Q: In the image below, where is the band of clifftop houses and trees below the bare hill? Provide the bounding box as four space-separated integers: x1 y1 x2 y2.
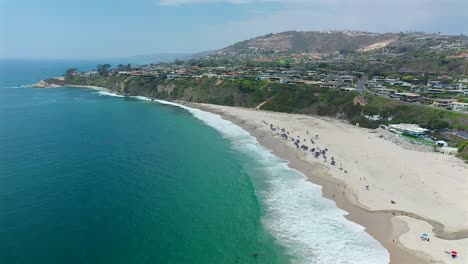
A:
74 64 468 112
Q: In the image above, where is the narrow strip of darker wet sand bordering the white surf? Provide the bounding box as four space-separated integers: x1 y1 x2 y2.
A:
194 103 432 264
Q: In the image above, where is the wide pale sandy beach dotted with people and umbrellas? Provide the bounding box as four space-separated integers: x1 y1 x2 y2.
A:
196 104 468 264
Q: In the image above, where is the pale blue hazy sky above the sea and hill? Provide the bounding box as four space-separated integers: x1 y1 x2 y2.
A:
0 0 468 59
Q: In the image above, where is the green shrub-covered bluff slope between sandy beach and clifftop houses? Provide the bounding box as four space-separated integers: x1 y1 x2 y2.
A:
63 74 468 133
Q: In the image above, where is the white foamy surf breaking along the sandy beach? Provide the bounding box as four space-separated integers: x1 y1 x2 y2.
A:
156 100 390 264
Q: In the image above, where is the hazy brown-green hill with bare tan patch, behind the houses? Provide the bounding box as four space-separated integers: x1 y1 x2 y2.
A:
214 31 468 75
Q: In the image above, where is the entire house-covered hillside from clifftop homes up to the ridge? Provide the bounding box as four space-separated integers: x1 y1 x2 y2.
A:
62 31 468 112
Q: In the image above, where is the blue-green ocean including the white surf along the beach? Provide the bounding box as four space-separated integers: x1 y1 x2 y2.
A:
0 61 389 264
